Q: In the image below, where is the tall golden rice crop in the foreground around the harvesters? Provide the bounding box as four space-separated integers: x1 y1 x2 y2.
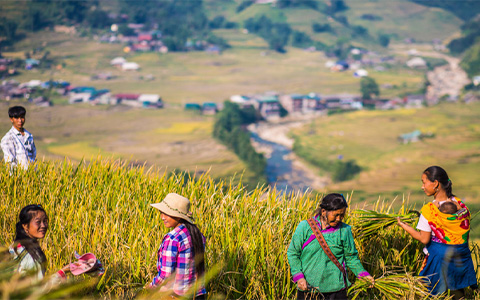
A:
0 158 480 299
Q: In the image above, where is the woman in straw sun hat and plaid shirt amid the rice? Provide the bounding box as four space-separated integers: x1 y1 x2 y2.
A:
149 193 207 299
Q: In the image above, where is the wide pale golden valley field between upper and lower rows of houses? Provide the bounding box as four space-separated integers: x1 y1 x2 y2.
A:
2 29 423 105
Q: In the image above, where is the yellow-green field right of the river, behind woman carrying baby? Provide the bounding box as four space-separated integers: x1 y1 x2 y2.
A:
292 103 480 207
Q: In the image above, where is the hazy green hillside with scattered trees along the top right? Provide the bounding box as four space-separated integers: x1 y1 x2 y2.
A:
204 0 463 47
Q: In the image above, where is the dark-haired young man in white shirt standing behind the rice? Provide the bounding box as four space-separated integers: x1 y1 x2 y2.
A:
1 106 37 169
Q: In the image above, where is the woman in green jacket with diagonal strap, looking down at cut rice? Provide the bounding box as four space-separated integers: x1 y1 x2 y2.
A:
287 193 374 300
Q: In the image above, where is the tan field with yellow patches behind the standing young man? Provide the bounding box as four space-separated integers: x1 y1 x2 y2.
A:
0 102 245 177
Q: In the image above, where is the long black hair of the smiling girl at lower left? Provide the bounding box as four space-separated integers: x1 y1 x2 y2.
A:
14 204 47 264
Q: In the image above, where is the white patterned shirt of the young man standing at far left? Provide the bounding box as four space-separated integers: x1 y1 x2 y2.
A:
1 126 37 169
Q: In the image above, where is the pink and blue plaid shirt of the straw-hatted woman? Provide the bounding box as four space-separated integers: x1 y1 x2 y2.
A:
151 224 207 296
